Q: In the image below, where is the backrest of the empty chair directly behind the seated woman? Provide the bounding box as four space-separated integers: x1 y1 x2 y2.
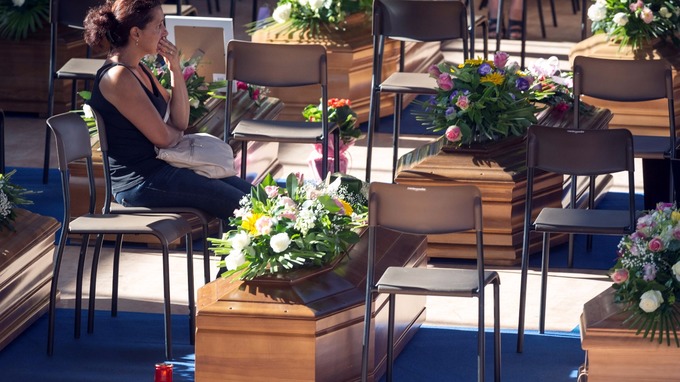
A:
47 112 96 224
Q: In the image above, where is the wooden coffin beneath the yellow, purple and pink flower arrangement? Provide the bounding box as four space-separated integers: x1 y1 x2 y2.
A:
395 109 611 265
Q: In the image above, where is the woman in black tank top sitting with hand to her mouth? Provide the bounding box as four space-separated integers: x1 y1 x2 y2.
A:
85 0 251 220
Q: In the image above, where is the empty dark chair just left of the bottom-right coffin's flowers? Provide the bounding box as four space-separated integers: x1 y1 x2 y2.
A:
517 125 635 352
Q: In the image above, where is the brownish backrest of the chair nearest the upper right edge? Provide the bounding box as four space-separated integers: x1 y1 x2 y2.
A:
574 56 677 157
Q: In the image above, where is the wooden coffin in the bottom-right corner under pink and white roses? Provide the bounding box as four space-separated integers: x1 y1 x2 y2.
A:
581 288 680 382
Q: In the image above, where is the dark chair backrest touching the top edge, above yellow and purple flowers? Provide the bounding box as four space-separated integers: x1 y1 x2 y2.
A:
373 0 468 46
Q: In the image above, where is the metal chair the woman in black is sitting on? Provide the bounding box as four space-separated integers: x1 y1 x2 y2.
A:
91 108 222 286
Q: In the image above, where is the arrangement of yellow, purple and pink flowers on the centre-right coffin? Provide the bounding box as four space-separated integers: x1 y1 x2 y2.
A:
414 52 539 146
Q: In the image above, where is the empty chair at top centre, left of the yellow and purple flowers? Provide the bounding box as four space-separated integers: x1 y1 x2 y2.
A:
366 0 488 182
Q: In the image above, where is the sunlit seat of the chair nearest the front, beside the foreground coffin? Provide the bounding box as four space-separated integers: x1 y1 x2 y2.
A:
376 267 500 297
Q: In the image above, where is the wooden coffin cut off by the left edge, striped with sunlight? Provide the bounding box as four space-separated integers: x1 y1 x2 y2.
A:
0 208 60 350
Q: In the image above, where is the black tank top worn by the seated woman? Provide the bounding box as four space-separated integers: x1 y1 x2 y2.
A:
88 62 169 195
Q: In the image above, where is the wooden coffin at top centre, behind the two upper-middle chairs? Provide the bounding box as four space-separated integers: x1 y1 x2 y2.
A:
252 14 444 123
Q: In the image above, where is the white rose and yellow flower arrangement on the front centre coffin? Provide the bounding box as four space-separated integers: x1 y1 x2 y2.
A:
209 174 368 280
